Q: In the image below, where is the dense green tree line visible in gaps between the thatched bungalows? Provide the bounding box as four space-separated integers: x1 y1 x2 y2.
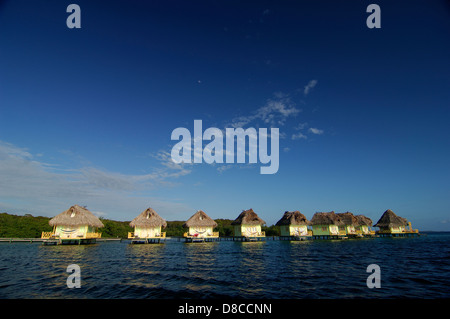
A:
0 213 280 238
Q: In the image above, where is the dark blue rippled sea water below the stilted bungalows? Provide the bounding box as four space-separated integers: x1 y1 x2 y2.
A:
0 233 450 299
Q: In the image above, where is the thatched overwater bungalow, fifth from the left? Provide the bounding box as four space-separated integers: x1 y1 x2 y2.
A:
275 211 312 239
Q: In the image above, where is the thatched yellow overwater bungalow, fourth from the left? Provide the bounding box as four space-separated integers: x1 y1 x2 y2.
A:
231 208 266 241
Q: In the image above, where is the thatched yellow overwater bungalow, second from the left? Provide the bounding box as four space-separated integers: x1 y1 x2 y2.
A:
128 208 167 244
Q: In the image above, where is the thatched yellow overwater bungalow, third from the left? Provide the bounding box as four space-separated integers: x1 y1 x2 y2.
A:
183 210 219 242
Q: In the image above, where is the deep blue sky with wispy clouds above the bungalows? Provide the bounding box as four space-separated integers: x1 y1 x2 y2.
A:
0 0 450 230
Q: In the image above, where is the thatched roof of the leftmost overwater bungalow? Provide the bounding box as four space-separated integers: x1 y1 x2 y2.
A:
48 205 104 227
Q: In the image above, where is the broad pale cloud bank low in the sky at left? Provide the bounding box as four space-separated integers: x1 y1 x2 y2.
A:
0 141 190 220
